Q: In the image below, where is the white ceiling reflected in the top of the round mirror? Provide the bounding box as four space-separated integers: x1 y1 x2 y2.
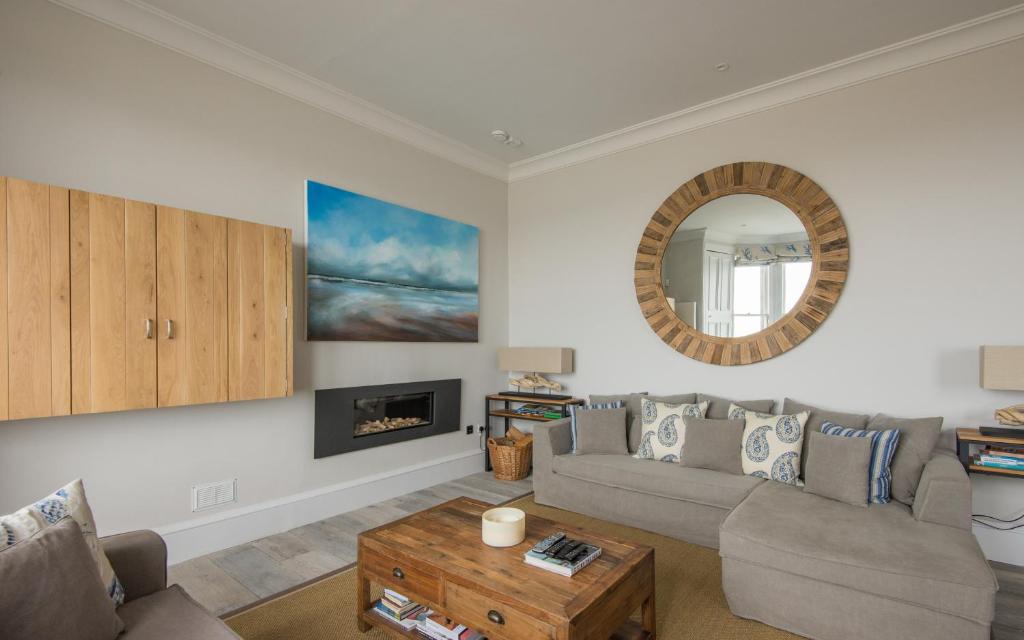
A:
677 194 807 237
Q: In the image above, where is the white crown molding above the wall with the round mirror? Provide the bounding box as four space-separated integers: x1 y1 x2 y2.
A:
509 4 1024 182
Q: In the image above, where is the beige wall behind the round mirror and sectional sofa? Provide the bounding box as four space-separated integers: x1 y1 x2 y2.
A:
509 41 1024 564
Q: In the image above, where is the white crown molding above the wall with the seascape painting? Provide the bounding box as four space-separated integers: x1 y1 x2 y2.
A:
50 0 508 181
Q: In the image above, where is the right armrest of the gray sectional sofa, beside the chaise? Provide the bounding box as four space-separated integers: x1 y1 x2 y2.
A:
913 454 971 530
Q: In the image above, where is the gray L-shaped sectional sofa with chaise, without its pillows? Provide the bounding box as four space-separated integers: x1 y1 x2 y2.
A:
534 395 997 640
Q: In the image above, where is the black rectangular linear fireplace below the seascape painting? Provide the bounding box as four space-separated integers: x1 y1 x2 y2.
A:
313 379 462 458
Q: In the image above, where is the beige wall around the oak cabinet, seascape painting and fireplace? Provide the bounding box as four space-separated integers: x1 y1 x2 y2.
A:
0 1 508 531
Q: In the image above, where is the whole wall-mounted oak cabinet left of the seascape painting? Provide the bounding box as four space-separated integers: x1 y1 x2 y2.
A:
0 177 293 420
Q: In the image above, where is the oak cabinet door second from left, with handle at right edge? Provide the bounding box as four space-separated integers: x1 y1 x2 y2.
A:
71 191 157 413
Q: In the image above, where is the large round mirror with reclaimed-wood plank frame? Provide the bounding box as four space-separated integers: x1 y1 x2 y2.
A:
634 162 850 365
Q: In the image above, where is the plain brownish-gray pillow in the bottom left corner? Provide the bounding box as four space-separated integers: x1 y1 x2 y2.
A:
0 516 124 640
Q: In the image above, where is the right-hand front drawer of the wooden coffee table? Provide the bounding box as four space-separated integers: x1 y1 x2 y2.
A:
444 583 555 640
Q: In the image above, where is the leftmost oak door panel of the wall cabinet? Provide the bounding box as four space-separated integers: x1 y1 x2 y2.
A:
0 178 71 420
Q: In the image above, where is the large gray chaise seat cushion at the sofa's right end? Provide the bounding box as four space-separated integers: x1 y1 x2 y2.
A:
719 482 996 624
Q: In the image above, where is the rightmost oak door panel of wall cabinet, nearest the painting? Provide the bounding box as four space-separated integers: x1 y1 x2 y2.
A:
227 220 292 400
